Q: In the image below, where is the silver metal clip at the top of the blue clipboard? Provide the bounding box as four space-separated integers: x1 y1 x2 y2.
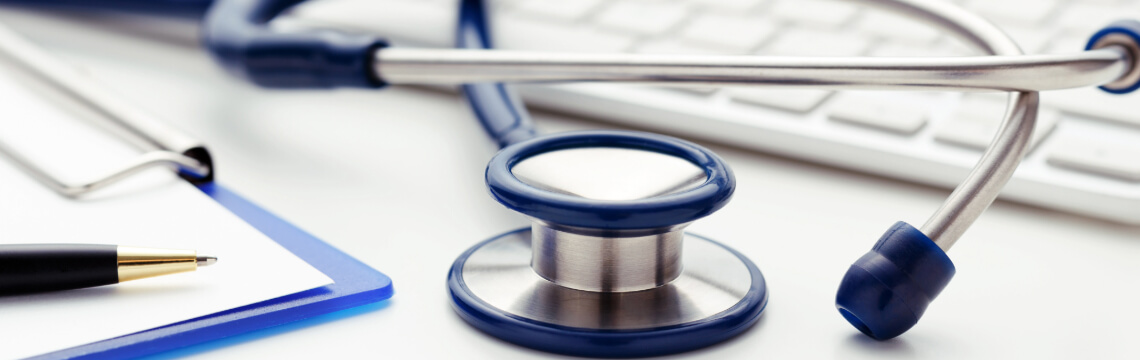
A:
0 25 213 198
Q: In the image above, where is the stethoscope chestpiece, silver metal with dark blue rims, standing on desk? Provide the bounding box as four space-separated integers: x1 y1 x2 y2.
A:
448 131 767 358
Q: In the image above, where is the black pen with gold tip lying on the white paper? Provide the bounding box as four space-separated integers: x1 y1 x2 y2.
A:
0 244 218 295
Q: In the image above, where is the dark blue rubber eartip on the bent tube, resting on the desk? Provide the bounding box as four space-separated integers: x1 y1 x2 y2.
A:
836 221 954 339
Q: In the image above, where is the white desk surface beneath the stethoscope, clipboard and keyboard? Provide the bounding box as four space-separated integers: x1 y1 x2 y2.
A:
0 7 1140 359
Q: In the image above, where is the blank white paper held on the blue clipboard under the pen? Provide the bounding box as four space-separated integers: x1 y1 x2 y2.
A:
0 61 332 359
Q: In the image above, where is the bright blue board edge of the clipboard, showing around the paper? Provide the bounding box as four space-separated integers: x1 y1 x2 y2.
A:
32 182 392 359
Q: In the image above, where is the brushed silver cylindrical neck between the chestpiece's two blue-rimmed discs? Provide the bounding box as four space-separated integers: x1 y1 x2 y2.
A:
530 222 685 293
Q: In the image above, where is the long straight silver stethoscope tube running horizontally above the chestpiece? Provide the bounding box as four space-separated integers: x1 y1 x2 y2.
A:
373 48 1129 91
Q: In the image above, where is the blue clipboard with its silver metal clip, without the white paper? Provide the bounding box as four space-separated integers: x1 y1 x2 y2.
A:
0 20 392 359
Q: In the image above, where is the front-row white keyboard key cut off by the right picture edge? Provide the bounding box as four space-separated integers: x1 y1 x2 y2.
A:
1048 138 1140 181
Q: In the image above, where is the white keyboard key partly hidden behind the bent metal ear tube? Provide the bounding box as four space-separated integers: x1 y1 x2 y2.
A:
934 97 1060 152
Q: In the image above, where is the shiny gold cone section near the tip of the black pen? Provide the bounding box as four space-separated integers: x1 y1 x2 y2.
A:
117 246 198 283
